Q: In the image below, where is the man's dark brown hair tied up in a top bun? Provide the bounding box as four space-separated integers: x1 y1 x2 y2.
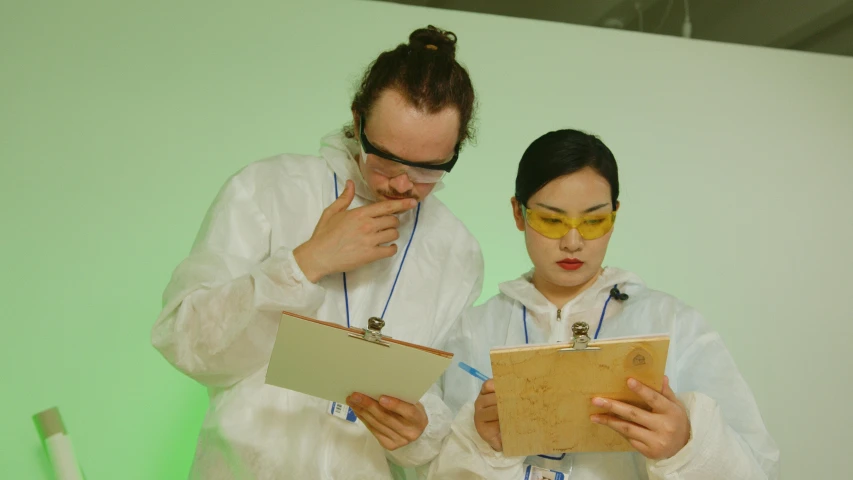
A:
346 25 475 144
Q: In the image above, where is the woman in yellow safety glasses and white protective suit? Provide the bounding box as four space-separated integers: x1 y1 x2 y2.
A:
430 130 779 480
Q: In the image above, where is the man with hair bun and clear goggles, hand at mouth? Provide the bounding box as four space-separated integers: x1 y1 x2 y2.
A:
152 26 483 480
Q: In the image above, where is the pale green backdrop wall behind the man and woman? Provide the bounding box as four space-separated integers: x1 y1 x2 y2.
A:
5 0 853 480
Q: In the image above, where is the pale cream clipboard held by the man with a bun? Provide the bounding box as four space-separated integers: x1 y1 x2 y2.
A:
265 312 453 404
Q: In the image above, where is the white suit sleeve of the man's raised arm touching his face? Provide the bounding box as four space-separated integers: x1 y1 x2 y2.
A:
151 173 325 388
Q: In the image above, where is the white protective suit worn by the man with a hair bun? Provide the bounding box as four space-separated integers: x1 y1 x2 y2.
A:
152 133 483 480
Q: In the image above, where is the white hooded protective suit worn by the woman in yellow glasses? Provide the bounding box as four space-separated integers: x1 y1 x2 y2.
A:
430 268 779 480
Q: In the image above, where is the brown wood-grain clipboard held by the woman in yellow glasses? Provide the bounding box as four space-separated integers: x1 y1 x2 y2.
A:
490 322 669 456
